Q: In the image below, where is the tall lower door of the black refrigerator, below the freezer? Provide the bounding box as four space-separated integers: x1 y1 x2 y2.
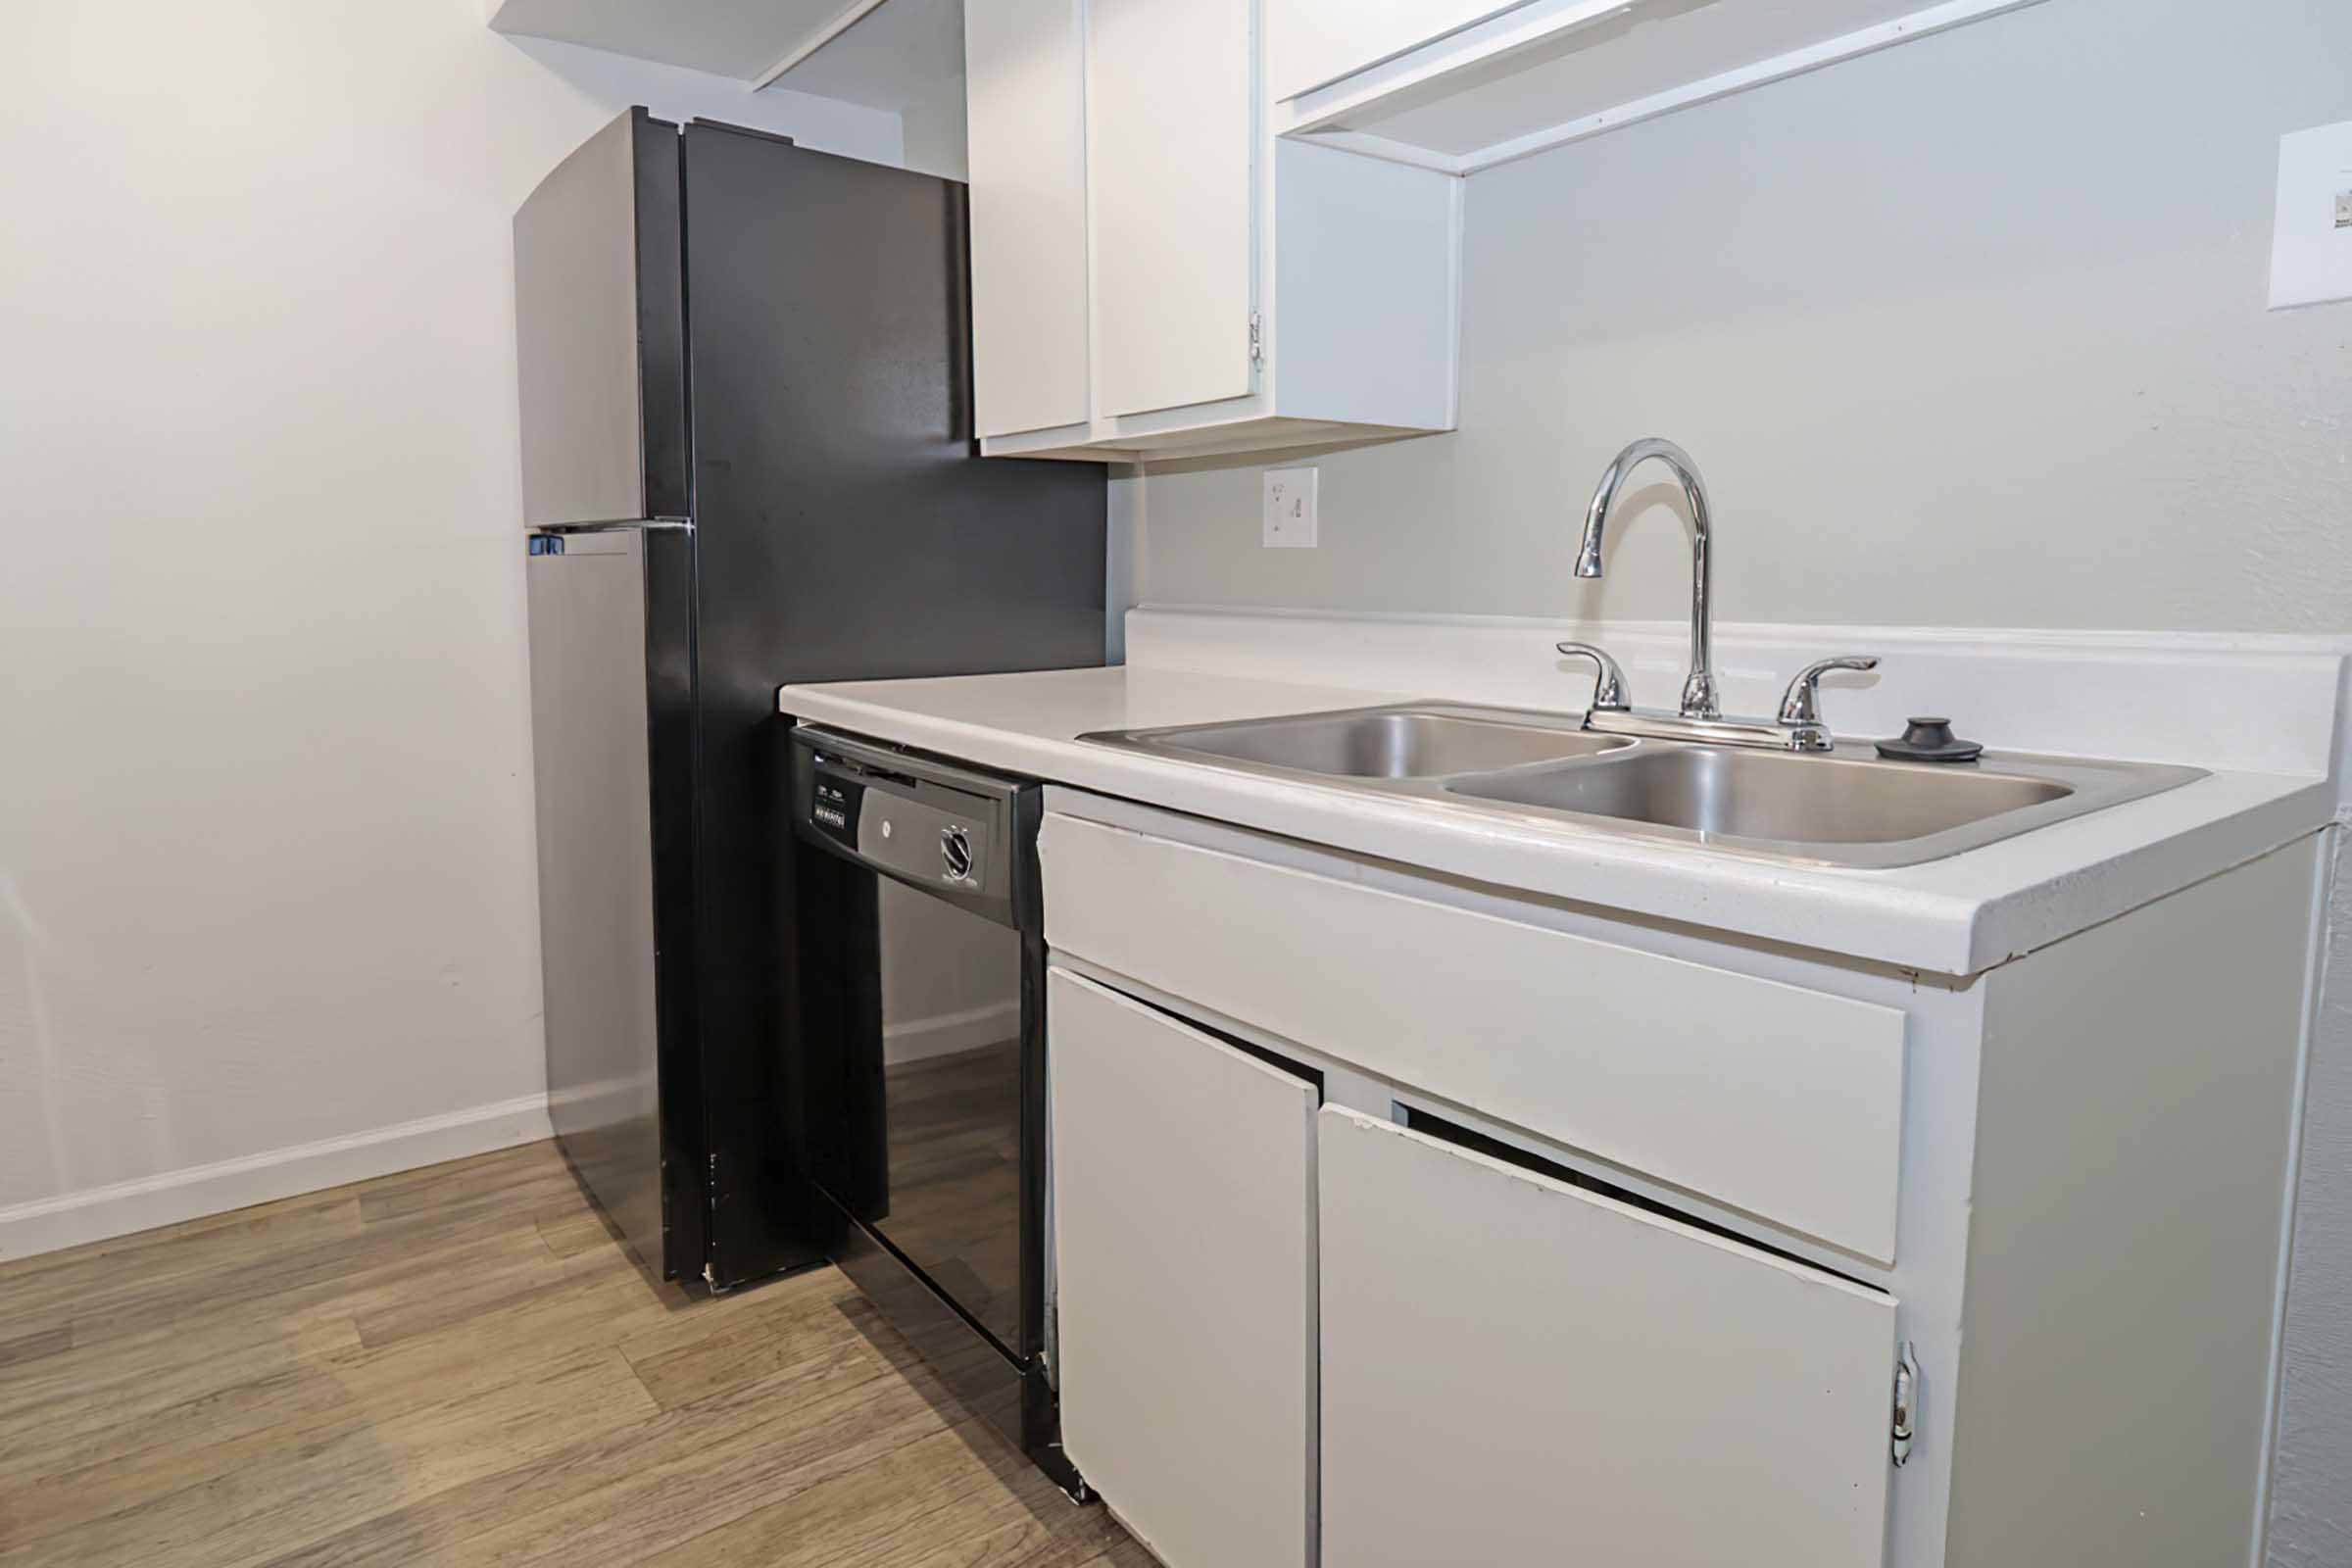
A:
527 531 677 1274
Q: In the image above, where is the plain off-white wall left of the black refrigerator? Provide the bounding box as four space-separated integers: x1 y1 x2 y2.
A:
0 0 899 1257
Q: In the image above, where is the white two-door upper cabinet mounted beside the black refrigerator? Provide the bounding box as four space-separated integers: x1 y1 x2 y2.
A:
966 0 1460 461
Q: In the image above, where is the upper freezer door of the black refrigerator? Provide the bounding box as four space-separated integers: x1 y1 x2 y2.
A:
515 108 687 529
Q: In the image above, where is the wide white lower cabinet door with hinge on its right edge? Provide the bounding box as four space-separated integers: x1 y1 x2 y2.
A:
1319 1107 1895 1568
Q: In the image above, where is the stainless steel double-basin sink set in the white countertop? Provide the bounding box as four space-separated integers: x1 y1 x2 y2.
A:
1082 703 2204 867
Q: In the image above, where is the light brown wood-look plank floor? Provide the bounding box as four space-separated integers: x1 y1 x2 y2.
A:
0 1145 1151 1568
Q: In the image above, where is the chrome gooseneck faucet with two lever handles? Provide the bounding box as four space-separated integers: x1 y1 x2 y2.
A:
1559 437 1880 753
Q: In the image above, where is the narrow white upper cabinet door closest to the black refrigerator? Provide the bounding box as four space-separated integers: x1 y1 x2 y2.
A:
964 0 1089 435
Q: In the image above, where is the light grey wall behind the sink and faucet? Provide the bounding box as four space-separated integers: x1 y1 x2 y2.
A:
1134 0 2352 1568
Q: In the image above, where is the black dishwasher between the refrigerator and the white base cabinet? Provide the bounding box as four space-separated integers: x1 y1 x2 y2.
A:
793 726 1084 1495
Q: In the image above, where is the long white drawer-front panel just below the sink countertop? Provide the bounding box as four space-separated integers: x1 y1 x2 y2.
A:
1040 813 1903 1262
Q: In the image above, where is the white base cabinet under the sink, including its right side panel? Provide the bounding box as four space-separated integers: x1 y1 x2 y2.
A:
1037 790 2333 1568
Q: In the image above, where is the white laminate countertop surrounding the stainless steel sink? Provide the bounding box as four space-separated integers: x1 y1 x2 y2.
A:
778 665 2335 976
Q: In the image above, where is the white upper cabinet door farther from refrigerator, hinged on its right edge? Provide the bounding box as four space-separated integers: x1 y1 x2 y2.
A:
1087 0 1256 416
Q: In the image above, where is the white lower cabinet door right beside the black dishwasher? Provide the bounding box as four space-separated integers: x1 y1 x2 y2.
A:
1047 968 1339 1568
